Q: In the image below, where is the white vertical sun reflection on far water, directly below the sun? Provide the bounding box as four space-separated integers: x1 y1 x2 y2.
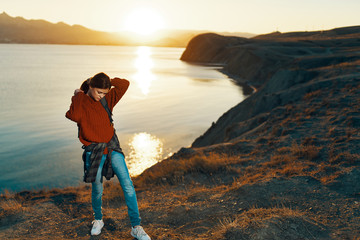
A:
133 46 156 96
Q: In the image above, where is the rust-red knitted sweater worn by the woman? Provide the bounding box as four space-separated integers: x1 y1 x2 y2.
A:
65 78 130 151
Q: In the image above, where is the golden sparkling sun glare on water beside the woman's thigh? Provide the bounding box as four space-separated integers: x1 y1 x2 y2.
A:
127 132 163 176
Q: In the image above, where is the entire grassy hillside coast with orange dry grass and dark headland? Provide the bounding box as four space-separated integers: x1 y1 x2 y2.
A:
0 25 360 240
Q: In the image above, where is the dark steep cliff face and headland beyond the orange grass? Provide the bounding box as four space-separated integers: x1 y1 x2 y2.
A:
181 27 360 147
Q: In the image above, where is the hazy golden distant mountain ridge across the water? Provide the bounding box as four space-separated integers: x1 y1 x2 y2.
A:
0 12 254 47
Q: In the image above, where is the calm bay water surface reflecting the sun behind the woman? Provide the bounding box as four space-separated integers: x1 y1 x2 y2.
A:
0 44 245 192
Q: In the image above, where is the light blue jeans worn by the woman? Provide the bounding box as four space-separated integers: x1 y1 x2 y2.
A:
86 151 141 227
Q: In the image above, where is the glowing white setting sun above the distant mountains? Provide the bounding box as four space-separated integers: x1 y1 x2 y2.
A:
124 8 164 35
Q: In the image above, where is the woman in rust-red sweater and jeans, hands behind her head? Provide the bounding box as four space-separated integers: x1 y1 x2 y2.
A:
66 73 150 240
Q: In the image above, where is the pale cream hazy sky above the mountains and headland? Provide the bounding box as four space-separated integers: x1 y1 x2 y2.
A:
0 0 360 34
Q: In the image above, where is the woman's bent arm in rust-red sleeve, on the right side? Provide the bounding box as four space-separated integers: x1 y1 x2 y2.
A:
105 78 130 111
